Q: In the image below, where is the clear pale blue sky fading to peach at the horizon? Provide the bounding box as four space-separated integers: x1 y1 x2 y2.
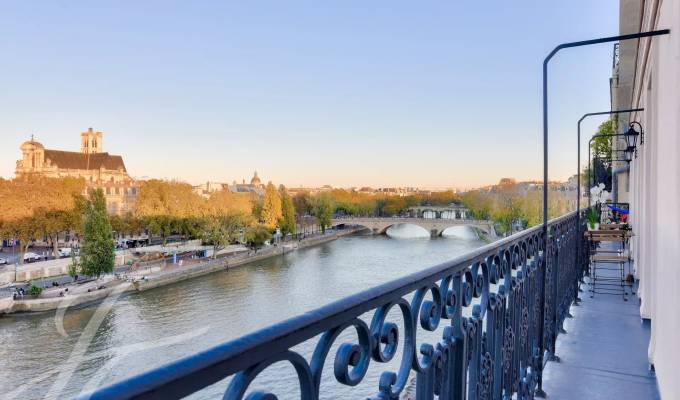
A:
0 0 618 189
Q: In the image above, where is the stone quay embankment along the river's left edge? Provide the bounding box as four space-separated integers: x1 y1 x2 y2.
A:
0 227 364 315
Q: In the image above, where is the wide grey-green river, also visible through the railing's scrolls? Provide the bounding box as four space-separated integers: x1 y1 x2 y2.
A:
0 226 484 399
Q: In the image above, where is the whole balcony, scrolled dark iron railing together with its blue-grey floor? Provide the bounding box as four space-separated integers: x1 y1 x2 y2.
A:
78 213 658 400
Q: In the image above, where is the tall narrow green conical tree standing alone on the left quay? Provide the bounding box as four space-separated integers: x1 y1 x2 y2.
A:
80 189 115 278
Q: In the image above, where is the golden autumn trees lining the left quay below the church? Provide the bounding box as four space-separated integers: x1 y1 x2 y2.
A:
0 175 334 261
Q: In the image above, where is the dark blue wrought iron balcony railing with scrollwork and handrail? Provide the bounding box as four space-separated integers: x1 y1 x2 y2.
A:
82 213 587 400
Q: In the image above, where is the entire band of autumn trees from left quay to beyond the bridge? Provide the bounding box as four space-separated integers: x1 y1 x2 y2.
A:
0 176 567 266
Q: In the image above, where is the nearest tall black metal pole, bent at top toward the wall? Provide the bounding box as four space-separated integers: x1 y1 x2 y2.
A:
537 29 670 395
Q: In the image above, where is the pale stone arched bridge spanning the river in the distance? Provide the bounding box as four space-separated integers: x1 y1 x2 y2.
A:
331 217 496 237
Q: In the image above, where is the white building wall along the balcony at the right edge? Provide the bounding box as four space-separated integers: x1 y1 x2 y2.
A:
612 0 680 399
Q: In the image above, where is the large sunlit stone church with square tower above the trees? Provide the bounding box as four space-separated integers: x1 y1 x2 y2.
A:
16 128 137 215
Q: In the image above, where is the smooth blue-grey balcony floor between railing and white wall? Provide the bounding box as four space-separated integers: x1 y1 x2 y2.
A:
543 260 659 400
